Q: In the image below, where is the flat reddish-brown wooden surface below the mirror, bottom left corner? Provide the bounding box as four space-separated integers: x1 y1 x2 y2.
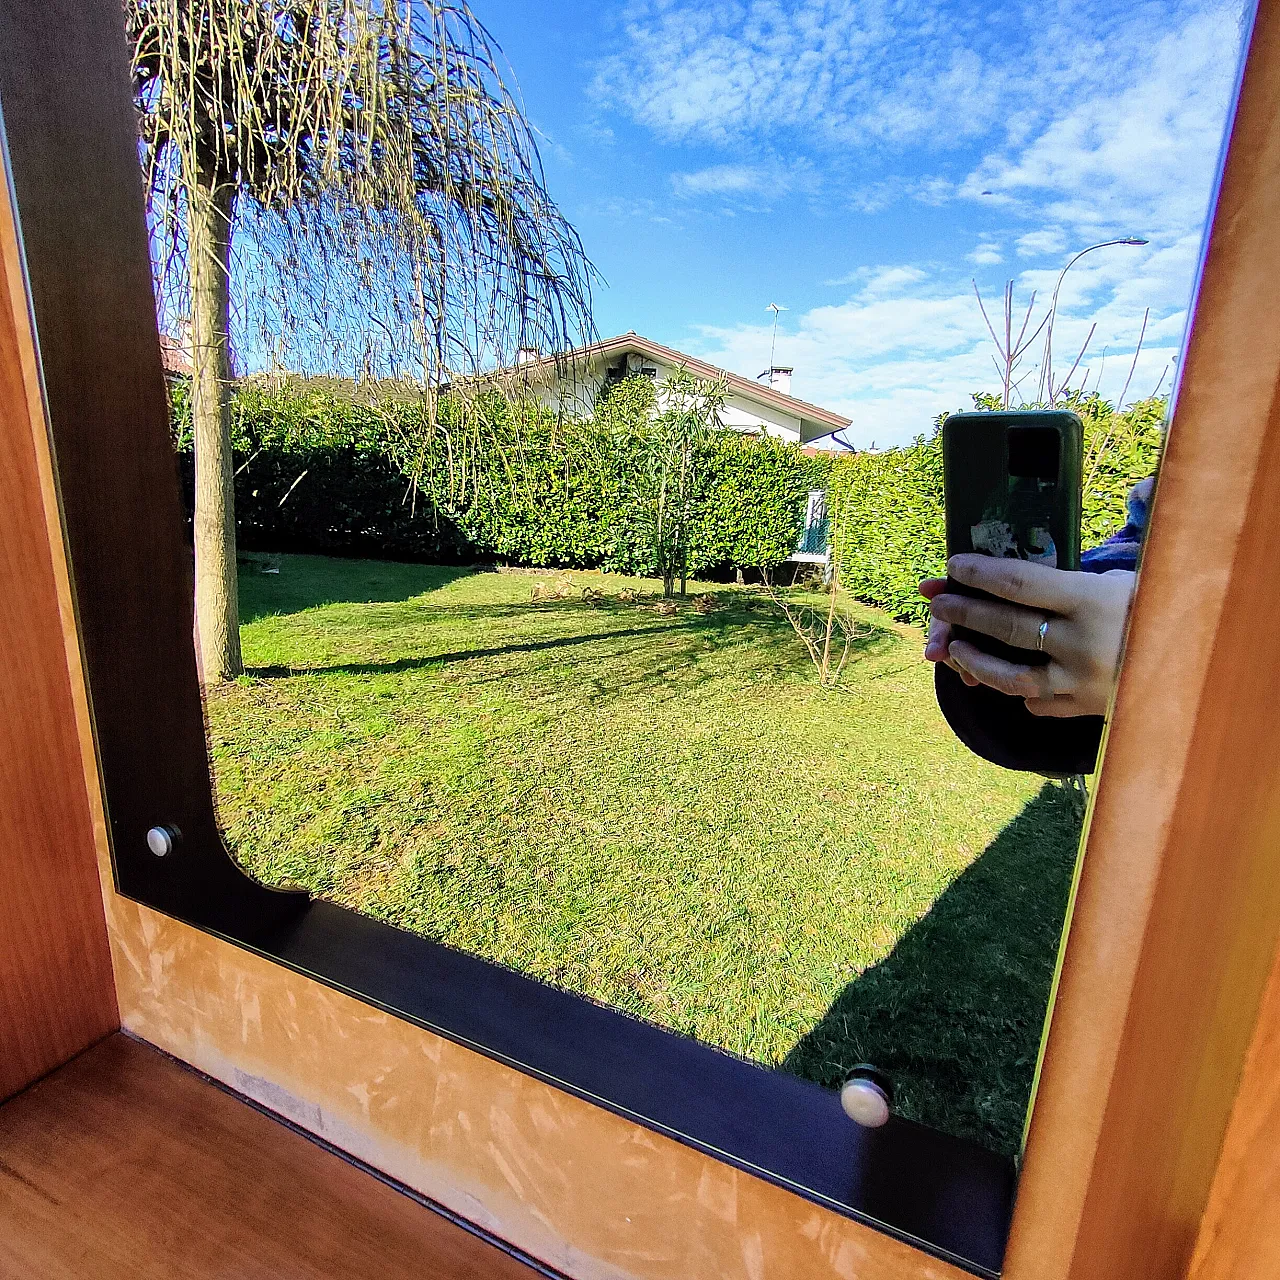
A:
0 1034 548 1280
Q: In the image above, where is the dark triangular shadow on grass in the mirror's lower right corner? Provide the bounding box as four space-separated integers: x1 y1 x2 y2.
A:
782 783 1080 1155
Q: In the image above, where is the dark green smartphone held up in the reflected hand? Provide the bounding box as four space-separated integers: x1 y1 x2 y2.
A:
942 410 1084 663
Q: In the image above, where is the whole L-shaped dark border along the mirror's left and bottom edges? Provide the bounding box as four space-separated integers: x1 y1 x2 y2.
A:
0 0 1014 1276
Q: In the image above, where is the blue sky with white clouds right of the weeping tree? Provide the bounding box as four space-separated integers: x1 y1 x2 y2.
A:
474 0 1242 447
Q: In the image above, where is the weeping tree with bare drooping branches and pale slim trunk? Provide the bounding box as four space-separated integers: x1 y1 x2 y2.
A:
124 0 593 681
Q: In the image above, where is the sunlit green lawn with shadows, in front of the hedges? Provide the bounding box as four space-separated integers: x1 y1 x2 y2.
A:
209 556 1078 1151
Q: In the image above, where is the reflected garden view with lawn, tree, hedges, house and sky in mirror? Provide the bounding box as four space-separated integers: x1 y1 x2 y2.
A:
137 0 1240 1155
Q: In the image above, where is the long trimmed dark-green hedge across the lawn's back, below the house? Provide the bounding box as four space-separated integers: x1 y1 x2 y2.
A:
173 379 828 573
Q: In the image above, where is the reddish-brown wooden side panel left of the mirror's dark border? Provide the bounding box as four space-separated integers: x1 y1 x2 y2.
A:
0 110 118 1098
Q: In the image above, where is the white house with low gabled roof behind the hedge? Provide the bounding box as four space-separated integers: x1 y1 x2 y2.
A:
504 332 850 444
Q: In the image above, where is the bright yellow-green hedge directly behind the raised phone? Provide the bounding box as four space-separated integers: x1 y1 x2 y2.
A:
828 396 1166 622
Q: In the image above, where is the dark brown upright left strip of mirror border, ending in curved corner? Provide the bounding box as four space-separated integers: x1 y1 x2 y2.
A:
0 0 305 929
